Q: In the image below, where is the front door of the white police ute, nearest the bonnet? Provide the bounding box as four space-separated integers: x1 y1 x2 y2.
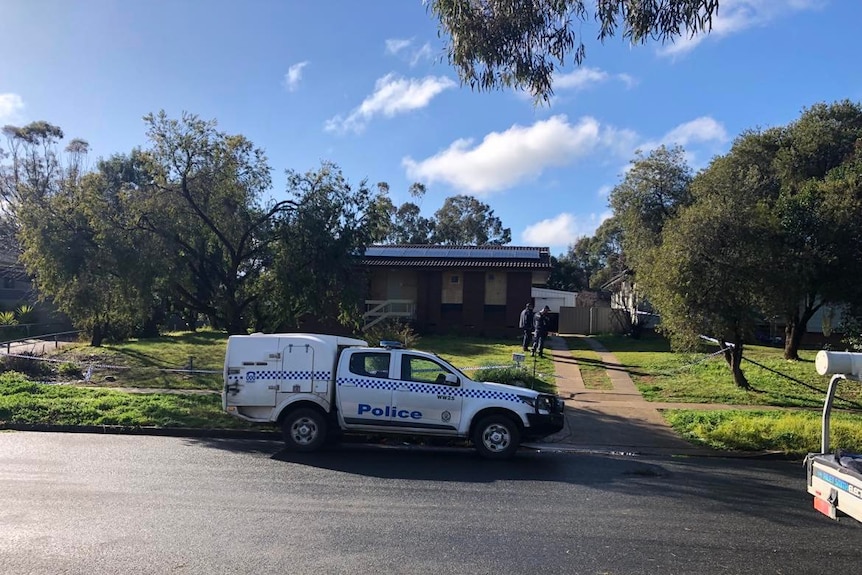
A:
392 352 464 434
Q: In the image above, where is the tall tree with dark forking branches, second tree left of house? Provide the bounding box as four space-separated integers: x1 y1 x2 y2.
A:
135 111 280 333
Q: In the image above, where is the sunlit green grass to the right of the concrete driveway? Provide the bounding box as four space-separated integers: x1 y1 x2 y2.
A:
597 334 862 456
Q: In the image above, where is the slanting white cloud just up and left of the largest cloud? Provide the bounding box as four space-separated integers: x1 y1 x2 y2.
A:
324 74 457 133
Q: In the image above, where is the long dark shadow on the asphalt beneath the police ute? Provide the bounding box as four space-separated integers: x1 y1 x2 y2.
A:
187 438 811 525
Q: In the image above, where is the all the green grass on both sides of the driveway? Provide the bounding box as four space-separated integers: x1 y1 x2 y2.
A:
6 331 862 454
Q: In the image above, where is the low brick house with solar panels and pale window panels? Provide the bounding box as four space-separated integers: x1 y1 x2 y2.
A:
361 245 551 337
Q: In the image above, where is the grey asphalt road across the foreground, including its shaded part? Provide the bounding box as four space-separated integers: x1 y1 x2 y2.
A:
0 432 862 575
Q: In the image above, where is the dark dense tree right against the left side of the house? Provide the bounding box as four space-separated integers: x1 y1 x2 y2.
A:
254 163 389 331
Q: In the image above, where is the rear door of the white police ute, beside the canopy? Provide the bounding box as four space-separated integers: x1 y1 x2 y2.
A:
336 351 394 427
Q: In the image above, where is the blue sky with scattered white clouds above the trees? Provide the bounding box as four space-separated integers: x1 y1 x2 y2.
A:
0 0 862 255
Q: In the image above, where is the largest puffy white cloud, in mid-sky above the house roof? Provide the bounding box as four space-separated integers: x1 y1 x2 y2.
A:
401 115 635 195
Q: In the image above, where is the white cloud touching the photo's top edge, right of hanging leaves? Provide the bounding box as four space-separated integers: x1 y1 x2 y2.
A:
658 0 825 56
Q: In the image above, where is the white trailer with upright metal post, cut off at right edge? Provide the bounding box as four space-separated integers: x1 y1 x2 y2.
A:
805 351 862 522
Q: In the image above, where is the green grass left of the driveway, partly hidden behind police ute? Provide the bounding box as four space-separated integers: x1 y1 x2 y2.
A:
0 331 553 428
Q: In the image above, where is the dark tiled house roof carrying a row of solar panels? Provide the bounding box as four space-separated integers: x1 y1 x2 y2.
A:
361 245 551 270
